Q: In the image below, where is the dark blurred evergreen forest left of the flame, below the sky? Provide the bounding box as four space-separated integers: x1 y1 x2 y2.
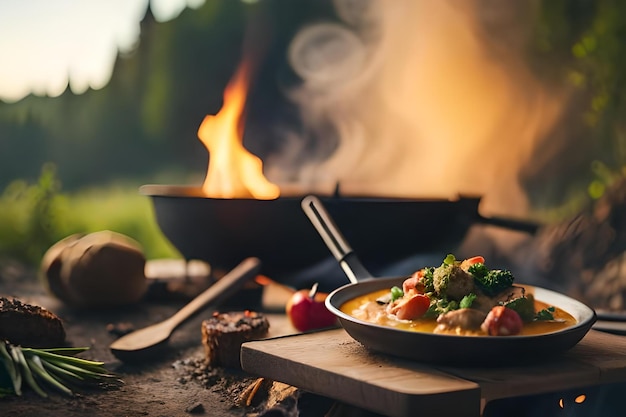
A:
0 1 250 190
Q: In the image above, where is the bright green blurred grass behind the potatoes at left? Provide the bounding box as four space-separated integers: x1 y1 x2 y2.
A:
0 166 181 265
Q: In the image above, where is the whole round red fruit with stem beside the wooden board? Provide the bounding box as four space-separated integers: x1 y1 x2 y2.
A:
285 283 337 332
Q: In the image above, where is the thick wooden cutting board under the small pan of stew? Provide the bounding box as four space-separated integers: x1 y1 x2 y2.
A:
241 329 626 417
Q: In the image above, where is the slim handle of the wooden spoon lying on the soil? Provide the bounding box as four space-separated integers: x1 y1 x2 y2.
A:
169 258 261 328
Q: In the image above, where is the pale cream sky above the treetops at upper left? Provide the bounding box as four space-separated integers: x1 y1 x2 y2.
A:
0 0 205 103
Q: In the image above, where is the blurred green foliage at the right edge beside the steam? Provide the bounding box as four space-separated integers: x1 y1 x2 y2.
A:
526 0 626 206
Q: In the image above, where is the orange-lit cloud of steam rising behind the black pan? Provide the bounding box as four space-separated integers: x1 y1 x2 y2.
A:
278 0 564 215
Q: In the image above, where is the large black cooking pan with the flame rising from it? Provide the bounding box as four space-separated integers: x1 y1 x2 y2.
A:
140 185 537 279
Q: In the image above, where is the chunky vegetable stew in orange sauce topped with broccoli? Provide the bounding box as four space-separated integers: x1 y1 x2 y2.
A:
341 255 576 336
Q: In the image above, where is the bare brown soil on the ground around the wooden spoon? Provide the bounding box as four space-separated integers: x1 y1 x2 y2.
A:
0 265 323 417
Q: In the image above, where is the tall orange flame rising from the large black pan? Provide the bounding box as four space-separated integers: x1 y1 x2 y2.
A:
198 63 280 200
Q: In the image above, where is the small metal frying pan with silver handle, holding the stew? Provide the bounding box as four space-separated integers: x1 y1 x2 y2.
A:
302 196 596 366
